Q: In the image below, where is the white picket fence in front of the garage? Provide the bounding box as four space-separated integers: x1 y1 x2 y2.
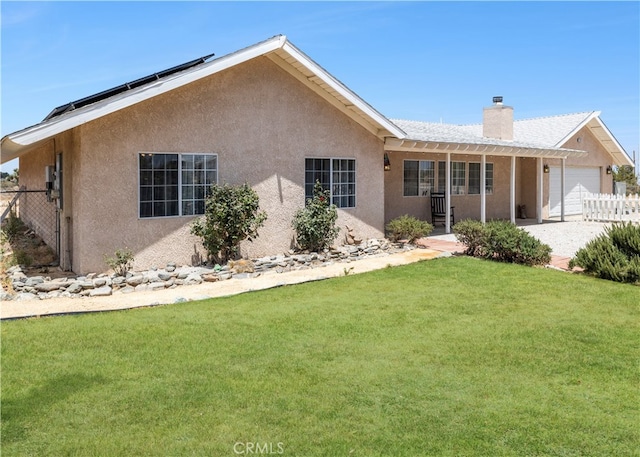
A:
582 194 640 223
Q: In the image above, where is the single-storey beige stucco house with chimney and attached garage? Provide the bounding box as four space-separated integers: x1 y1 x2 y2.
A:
2 36 630 273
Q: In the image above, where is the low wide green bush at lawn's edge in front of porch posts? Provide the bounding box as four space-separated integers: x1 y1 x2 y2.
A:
453 221 551 266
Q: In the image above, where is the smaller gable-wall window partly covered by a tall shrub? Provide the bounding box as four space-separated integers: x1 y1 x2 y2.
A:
304 158 356 208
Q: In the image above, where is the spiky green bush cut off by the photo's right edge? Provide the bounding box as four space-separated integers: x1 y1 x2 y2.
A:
569 222 640 284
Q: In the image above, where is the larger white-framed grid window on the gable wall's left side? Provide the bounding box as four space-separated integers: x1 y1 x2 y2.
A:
138 153 218 218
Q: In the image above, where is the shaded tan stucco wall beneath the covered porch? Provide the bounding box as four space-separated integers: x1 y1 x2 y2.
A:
385 152 511 223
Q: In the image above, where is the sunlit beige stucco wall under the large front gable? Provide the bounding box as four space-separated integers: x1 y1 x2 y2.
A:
43 57 384 273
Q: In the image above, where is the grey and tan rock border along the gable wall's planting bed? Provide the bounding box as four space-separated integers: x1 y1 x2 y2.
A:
0 239 415 301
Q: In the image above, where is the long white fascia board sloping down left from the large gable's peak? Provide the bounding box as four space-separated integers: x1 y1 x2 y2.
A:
2 36 286 152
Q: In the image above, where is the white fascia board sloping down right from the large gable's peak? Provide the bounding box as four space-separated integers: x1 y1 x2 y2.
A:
282 41 407 138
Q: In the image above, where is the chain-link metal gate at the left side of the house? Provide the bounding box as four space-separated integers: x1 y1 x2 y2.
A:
0 189 60 262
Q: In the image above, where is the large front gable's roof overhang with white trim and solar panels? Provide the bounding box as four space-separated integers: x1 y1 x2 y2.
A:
1 35 405 163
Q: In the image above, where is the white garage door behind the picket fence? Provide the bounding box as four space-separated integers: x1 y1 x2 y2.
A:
549 167 600 216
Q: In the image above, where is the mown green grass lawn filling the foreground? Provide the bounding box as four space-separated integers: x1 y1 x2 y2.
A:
2 258 640 457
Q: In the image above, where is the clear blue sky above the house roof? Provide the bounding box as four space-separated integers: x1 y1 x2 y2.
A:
0 1 640 171
